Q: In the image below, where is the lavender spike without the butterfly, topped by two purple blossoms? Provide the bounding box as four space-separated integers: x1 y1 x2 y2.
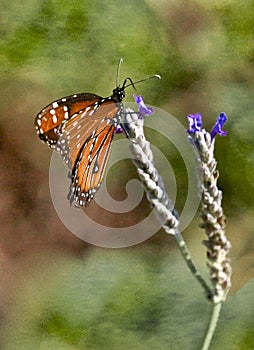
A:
188 113 232 304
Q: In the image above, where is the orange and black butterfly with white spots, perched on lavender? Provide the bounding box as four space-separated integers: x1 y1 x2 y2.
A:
35 60 158 207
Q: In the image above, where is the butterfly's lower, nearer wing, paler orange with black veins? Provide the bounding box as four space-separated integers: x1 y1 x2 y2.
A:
56 98 121 207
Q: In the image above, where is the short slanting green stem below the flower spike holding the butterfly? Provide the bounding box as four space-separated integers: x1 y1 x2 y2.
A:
174 230 213 300
